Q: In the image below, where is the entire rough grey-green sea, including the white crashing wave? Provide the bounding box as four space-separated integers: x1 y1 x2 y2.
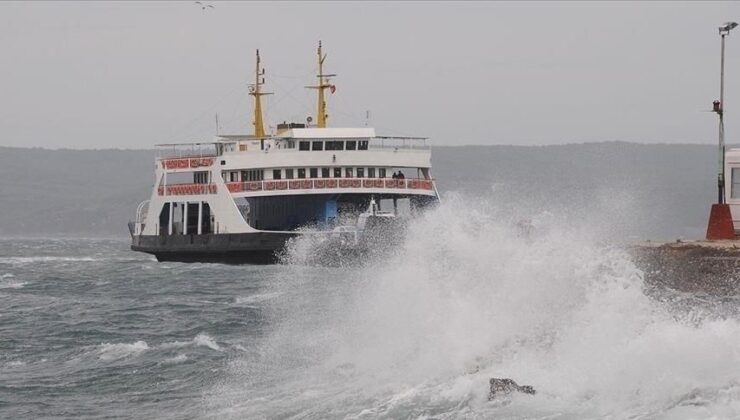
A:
0 200 740 419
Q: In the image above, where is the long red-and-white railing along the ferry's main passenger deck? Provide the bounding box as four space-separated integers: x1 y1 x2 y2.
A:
226 178 434 193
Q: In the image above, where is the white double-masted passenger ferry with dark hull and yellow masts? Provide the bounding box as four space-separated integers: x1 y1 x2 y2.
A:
129 43 439 263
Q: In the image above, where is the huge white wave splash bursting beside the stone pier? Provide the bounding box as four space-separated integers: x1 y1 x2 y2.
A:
205 197 740 418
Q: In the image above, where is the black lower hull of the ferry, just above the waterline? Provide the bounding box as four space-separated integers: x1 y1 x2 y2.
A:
131 232 296 264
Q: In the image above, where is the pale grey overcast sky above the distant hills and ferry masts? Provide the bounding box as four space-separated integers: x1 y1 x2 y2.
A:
0 1 740 148
